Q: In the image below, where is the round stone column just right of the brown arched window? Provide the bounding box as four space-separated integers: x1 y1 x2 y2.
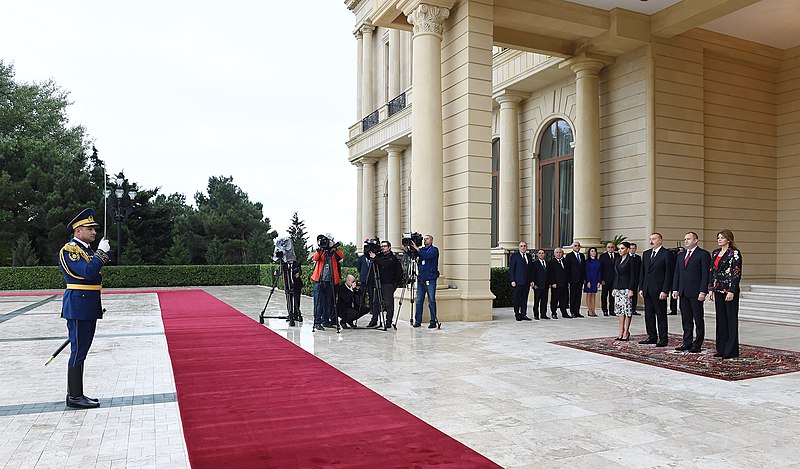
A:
567 54 613 246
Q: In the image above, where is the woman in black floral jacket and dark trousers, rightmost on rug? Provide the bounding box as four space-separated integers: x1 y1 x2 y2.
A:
708 230 742 358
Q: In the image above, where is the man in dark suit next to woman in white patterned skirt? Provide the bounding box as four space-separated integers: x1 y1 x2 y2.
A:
639 233 673 347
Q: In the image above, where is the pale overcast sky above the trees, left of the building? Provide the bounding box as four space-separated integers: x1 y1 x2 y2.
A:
0 0 356 242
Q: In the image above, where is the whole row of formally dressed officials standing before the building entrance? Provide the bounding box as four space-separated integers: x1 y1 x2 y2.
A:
508 230 742 358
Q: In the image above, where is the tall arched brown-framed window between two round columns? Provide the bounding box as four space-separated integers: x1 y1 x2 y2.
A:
538 119 574 249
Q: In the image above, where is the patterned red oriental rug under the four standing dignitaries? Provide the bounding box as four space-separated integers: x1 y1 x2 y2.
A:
551 334 800 381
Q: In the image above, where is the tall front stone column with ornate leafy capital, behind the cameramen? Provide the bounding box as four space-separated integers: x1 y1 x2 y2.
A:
403 3 450 256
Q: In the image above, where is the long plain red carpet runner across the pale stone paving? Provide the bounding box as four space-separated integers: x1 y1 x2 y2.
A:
158 290 498 469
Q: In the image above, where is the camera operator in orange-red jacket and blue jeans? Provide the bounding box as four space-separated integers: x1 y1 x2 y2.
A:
311 234 344 331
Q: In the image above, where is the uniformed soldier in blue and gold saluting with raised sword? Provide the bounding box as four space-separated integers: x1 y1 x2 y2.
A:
58 208 111 409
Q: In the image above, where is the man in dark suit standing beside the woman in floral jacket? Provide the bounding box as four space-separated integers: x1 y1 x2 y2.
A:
672 231 711 353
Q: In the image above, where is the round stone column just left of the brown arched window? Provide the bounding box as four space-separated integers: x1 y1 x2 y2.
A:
494 90 524 250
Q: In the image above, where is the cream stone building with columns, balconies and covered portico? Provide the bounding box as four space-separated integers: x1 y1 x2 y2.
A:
345 0 800 321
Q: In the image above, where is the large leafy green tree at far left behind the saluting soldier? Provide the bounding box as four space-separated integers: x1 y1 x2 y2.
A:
0 61 103 264
